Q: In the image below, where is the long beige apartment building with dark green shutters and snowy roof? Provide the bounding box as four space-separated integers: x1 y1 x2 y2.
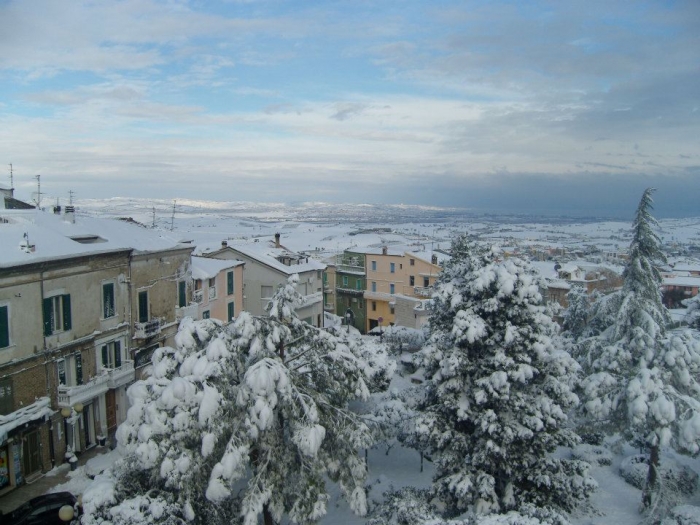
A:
0 206 192 495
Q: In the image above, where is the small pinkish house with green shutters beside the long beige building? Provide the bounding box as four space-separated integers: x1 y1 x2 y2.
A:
192 257 245 322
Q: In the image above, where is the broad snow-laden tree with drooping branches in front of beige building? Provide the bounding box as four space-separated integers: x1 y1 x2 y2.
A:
83 276 371 525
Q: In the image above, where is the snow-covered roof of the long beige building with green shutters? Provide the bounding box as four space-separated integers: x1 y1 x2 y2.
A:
0 209 189 267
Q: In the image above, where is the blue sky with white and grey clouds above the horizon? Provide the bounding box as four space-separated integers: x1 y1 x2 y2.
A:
0 0 700 217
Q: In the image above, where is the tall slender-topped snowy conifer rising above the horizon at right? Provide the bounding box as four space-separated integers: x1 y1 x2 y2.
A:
581 188 700 507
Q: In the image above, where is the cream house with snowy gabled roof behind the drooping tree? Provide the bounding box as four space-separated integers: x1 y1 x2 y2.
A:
203 234 326 327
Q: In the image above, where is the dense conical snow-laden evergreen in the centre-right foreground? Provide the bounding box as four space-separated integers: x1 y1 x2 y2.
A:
416 237 595 515
